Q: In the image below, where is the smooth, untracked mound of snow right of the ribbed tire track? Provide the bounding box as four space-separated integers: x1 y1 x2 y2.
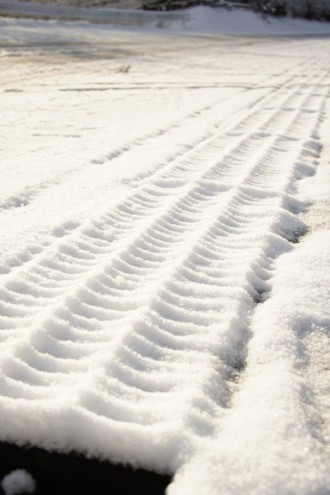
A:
168 232 330 495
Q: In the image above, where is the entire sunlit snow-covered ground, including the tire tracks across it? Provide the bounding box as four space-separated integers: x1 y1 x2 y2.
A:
0 11 330 495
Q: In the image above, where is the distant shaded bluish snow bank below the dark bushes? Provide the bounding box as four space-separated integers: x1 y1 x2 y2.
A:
0 0 330 36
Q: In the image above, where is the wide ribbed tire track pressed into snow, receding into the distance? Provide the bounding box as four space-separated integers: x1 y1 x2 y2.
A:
0 54 324 470
